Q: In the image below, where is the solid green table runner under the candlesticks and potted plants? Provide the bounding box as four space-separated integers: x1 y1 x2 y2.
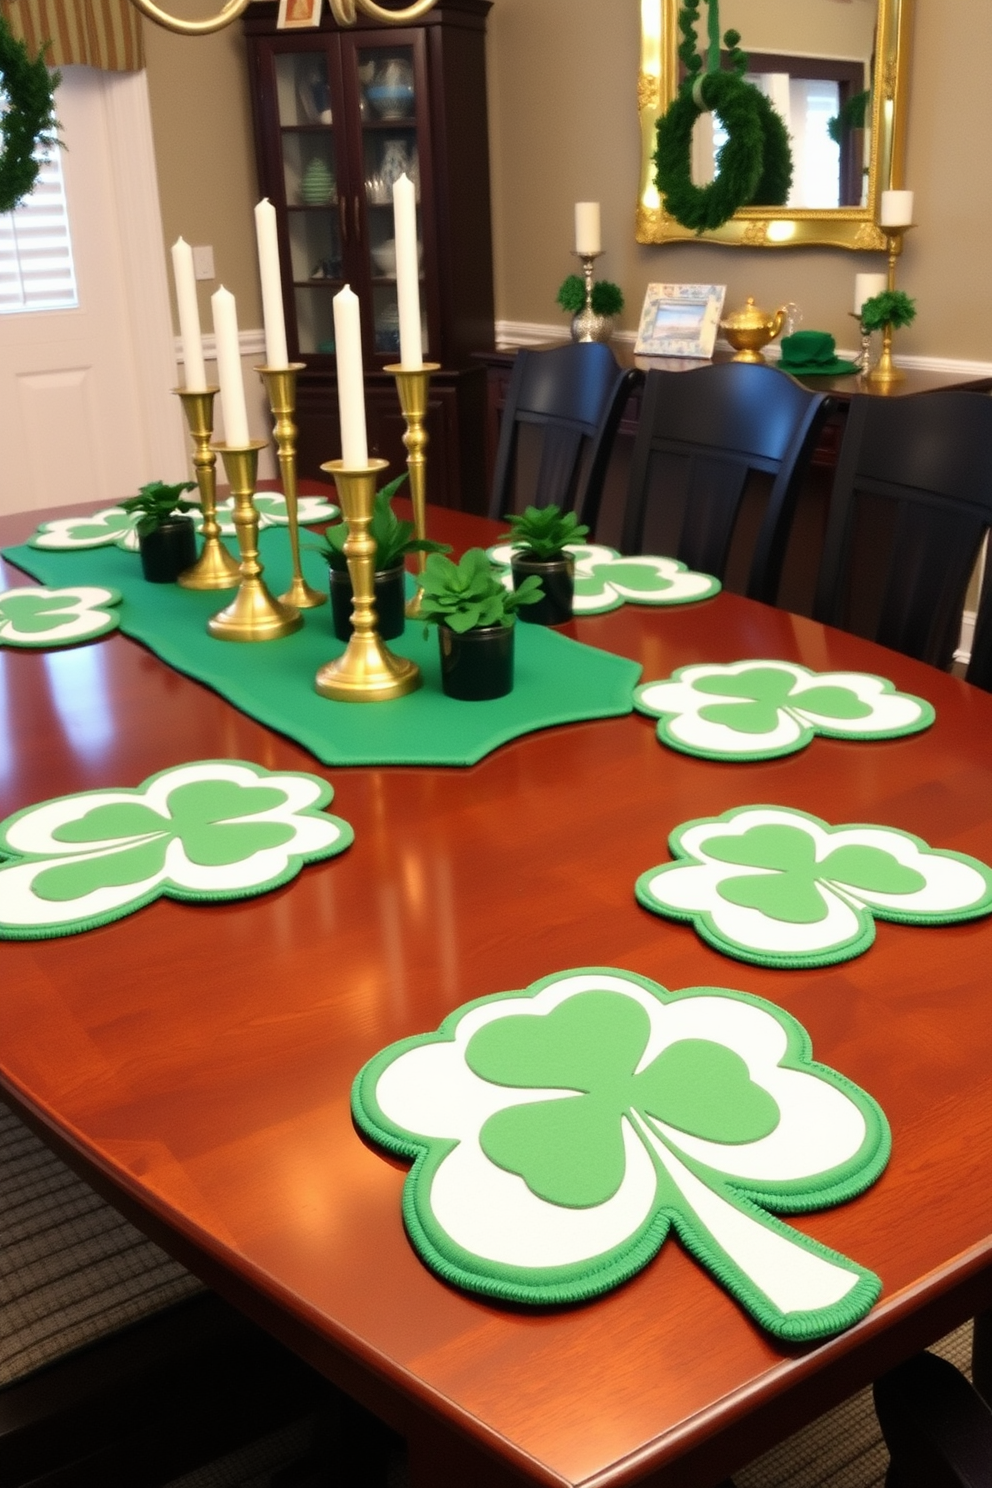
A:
4 527 641 765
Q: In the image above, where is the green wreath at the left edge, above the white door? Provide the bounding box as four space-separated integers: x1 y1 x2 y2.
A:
0 15 61 213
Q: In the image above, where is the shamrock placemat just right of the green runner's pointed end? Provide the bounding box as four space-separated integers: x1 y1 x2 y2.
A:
634 661 934 760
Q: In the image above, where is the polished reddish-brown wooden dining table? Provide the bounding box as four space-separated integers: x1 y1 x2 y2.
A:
0 499 992 1488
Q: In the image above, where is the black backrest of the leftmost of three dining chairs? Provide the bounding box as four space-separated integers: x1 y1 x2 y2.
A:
489 341 641 531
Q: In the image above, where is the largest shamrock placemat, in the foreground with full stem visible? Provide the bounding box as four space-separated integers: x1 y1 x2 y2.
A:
352 967 889 1339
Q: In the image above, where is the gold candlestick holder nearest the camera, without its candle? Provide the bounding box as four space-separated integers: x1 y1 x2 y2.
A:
315 460 421 702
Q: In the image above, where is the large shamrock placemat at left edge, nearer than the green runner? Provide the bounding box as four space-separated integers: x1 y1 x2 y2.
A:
0 759 354 940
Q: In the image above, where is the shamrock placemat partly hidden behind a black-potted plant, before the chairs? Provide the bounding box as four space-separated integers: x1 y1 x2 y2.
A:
486 543 721 615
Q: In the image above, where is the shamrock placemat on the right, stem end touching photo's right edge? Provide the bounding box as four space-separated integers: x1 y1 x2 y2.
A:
635 806 992 967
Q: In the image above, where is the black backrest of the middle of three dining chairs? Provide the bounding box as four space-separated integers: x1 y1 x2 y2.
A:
622 362 828 603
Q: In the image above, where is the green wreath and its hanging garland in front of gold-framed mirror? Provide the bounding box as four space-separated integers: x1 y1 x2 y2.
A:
653 0 793 232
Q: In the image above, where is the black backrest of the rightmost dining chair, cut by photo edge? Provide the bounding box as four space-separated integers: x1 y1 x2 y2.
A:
814 391 992 668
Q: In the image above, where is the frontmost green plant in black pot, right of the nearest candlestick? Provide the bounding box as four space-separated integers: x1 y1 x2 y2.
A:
421 548 541 702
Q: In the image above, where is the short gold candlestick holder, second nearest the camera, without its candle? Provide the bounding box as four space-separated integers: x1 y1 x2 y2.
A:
207 439 303 641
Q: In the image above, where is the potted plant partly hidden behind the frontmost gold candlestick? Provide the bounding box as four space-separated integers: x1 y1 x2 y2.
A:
318 473 451 641
